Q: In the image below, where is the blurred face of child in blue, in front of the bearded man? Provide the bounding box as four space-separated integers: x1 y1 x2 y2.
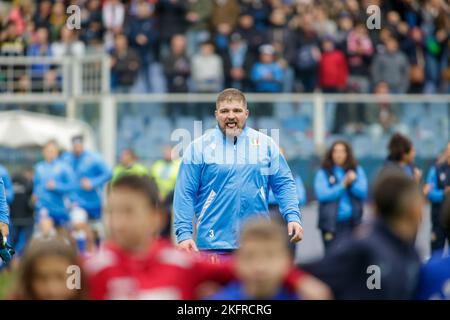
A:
236 238 290 298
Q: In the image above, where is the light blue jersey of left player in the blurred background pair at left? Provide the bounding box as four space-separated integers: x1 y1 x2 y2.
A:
33 159 75 219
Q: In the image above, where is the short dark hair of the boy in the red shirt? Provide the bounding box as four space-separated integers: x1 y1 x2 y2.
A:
108 175 162 209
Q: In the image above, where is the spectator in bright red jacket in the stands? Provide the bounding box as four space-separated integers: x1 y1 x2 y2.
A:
319 37 348 93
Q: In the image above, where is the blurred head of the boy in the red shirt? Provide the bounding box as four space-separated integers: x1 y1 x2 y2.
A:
105 175 164 252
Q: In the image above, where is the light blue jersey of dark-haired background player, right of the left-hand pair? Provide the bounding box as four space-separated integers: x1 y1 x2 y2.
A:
62 151 112 219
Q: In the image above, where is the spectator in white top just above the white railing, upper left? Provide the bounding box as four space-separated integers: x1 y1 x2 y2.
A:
52 26 86 58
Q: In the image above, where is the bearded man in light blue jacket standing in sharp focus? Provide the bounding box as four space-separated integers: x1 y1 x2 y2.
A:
174 89 303 254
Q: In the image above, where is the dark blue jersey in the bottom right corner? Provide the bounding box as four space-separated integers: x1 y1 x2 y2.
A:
417 251 450 300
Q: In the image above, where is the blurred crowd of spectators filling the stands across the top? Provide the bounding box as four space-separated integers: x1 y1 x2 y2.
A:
0 0 450 93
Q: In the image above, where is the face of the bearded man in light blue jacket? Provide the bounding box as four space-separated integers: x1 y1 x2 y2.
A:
215 100 248 137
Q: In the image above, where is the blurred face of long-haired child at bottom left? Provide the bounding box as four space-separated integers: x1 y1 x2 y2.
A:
31 256 76 300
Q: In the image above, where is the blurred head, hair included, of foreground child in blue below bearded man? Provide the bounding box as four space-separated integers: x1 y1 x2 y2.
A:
235 219 292 298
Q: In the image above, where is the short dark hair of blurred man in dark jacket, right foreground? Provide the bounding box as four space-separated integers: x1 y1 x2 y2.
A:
373 169 420 220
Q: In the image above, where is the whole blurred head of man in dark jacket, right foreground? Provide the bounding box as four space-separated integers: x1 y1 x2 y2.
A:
373 170 424 242
